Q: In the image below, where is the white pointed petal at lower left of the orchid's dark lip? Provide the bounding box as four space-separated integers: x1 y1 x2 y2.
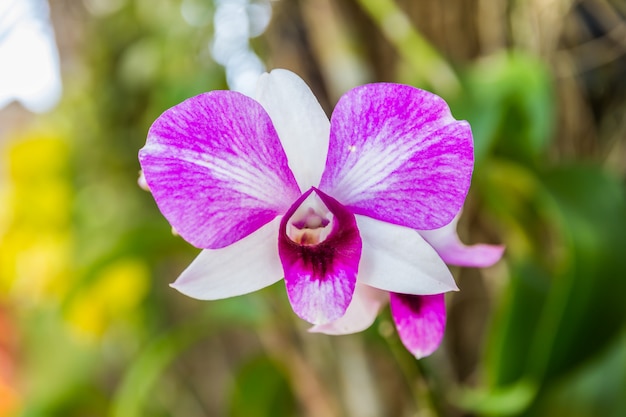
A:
172 217 283 300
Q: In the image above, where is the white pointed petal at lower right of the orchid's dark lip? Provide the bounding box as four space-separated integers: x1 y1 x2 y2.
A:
356 216 458 295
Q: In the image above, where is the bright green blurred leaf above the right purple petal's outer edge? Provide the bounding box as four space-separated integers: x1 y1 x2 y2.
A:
455 51 554 165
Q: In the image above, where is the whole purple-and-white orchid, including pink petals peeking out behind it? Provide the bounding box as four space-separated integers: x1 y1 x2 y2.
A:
139 70 502 357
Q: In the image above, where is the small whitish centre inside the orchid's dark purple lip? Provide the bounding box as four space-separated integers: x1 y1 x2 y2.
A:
287 192 333 245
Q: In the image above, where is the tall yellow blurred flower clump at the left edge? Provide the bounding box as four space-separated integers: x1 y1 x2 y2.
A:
0 132 73 305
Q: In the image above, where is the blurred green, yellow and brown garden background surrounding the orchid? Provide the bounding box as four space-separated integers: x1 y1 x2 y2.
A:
0 0 626 417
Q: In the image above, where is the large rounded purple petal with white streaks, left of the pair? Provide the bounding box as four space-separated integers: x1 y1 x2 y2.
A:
139 91 300 249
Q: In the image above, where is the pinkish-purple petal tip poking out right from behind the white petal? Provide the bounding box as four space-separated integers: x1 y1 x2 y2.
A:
418 213 504 268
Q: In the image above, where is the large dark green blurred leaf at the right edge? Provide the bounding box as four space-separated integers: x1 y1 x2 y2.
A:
472 166 626 412
